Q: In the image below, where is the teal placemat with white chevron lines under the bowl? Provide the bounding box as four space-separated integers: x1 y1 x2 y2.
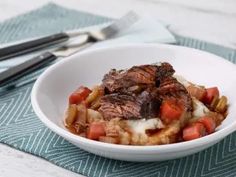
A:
0 4 236 177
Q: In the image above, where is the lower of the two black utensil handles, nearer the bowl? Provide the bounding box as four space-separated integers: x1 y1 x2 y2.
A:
0 52 57 87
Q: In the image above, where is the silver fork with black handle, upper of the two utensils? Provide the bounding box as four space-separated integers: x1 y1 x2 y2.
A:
0 11 138 61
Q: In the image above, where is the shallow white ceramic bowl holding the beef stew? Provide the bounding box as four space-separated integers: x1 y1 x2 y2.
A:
31 44 236 161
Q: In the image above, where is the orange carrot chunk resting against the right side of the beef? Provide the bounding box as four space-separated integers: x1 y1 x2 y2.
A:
160 100 183 123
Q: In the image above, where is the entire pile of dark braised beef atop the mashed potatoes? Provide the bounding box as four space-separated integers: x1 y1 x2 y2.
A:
98 63 192 120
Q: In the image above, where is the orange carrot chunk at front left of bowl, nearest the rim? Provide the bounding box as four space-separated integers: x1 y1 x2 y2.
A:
87 122 106 140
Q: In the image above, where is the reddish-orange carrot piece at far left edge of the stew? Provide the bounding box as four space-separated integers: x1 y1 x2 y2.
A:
69 86 91 104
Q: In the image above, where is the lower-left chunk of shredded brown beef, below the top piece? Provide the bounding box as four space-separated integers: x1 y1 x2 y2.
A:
98 91 161 120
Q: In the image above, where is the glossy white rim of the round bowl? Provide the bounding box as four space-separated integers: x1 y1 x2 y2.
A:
31 43 236 154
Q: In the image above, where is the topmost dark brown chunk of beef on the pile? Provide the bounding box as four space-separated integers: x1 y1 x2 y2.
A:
103 63 175 93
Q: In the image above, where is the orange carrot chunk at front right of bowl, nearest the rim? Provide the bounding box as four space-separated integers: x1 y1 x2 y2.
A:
183 122 206 141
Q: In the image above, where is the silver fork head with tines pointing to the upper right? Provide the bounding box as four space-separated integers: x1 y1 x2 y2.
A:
101 11 139 38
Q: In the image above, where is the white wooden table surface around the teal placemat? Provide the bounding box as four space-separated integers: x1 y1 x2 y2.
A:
0 0 236 177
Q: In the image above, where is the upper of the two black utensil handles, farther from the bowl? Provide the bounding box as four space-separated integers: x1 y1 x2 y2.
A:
0 33 69 61
